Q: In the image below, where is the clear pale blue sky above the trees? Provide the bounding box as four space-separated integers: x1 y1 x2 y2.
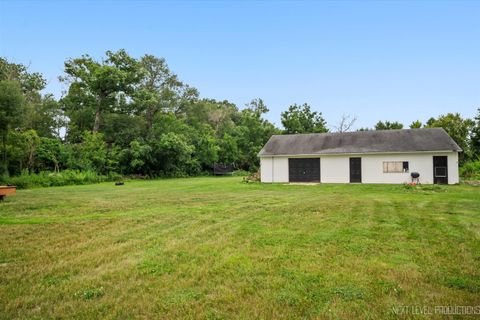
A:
0 0 480 128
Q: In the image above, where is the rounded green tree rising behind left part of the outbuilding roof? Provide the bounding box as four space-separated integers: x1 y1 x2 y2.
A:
281 103 328 133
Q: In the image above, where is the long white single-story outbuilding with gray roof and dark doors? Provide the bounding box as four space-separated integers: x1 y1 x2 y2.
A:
258 128 462 184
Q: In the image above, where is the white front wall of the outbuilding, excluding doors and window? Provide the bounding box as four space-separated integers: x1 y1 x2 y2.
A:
260 152 459 184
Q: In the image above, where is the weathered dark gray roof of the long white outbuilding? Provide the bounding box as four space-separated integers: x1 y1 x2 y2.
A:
258 128 462 157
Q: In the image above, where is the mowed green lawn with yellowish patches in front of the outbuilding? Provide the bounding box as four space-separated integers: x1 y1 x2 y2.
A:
0 177 480 319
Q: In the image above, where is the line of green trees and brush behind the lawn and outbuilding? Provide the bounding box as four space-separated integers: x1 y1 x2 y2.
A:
0 50 480 180
